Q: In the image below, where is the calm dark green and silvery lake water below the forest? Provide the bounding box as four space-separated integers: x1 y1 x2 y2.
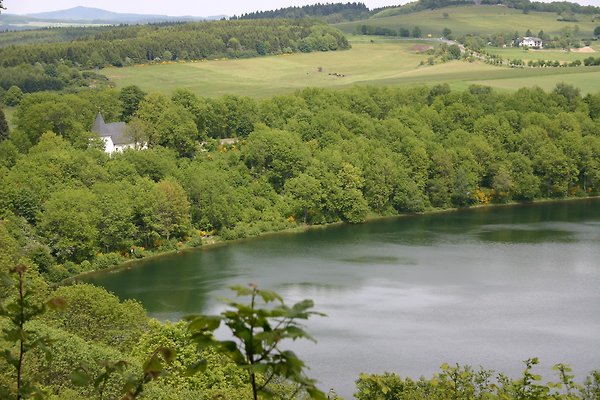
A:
88 199 600 398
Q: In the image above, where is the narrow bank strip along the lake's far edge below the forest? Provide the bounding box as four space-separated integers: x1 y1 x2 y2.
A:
62 196 600 286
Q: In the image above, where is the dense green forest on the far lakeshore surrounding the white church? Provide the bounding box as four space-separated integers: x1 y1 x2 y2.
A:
0 84 600 281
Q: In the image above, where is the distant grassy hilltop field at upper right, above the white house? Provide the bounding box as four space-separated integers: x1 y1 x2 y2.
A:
334 6 598 37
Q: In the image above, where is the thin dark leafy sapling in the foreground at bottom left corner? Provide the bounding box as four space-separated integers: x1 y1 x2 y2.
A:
0 265 65 399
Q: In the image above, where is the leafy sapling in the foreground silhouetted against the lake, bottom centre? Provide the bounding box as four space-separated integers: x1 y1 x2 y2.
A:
186 285 327 400
